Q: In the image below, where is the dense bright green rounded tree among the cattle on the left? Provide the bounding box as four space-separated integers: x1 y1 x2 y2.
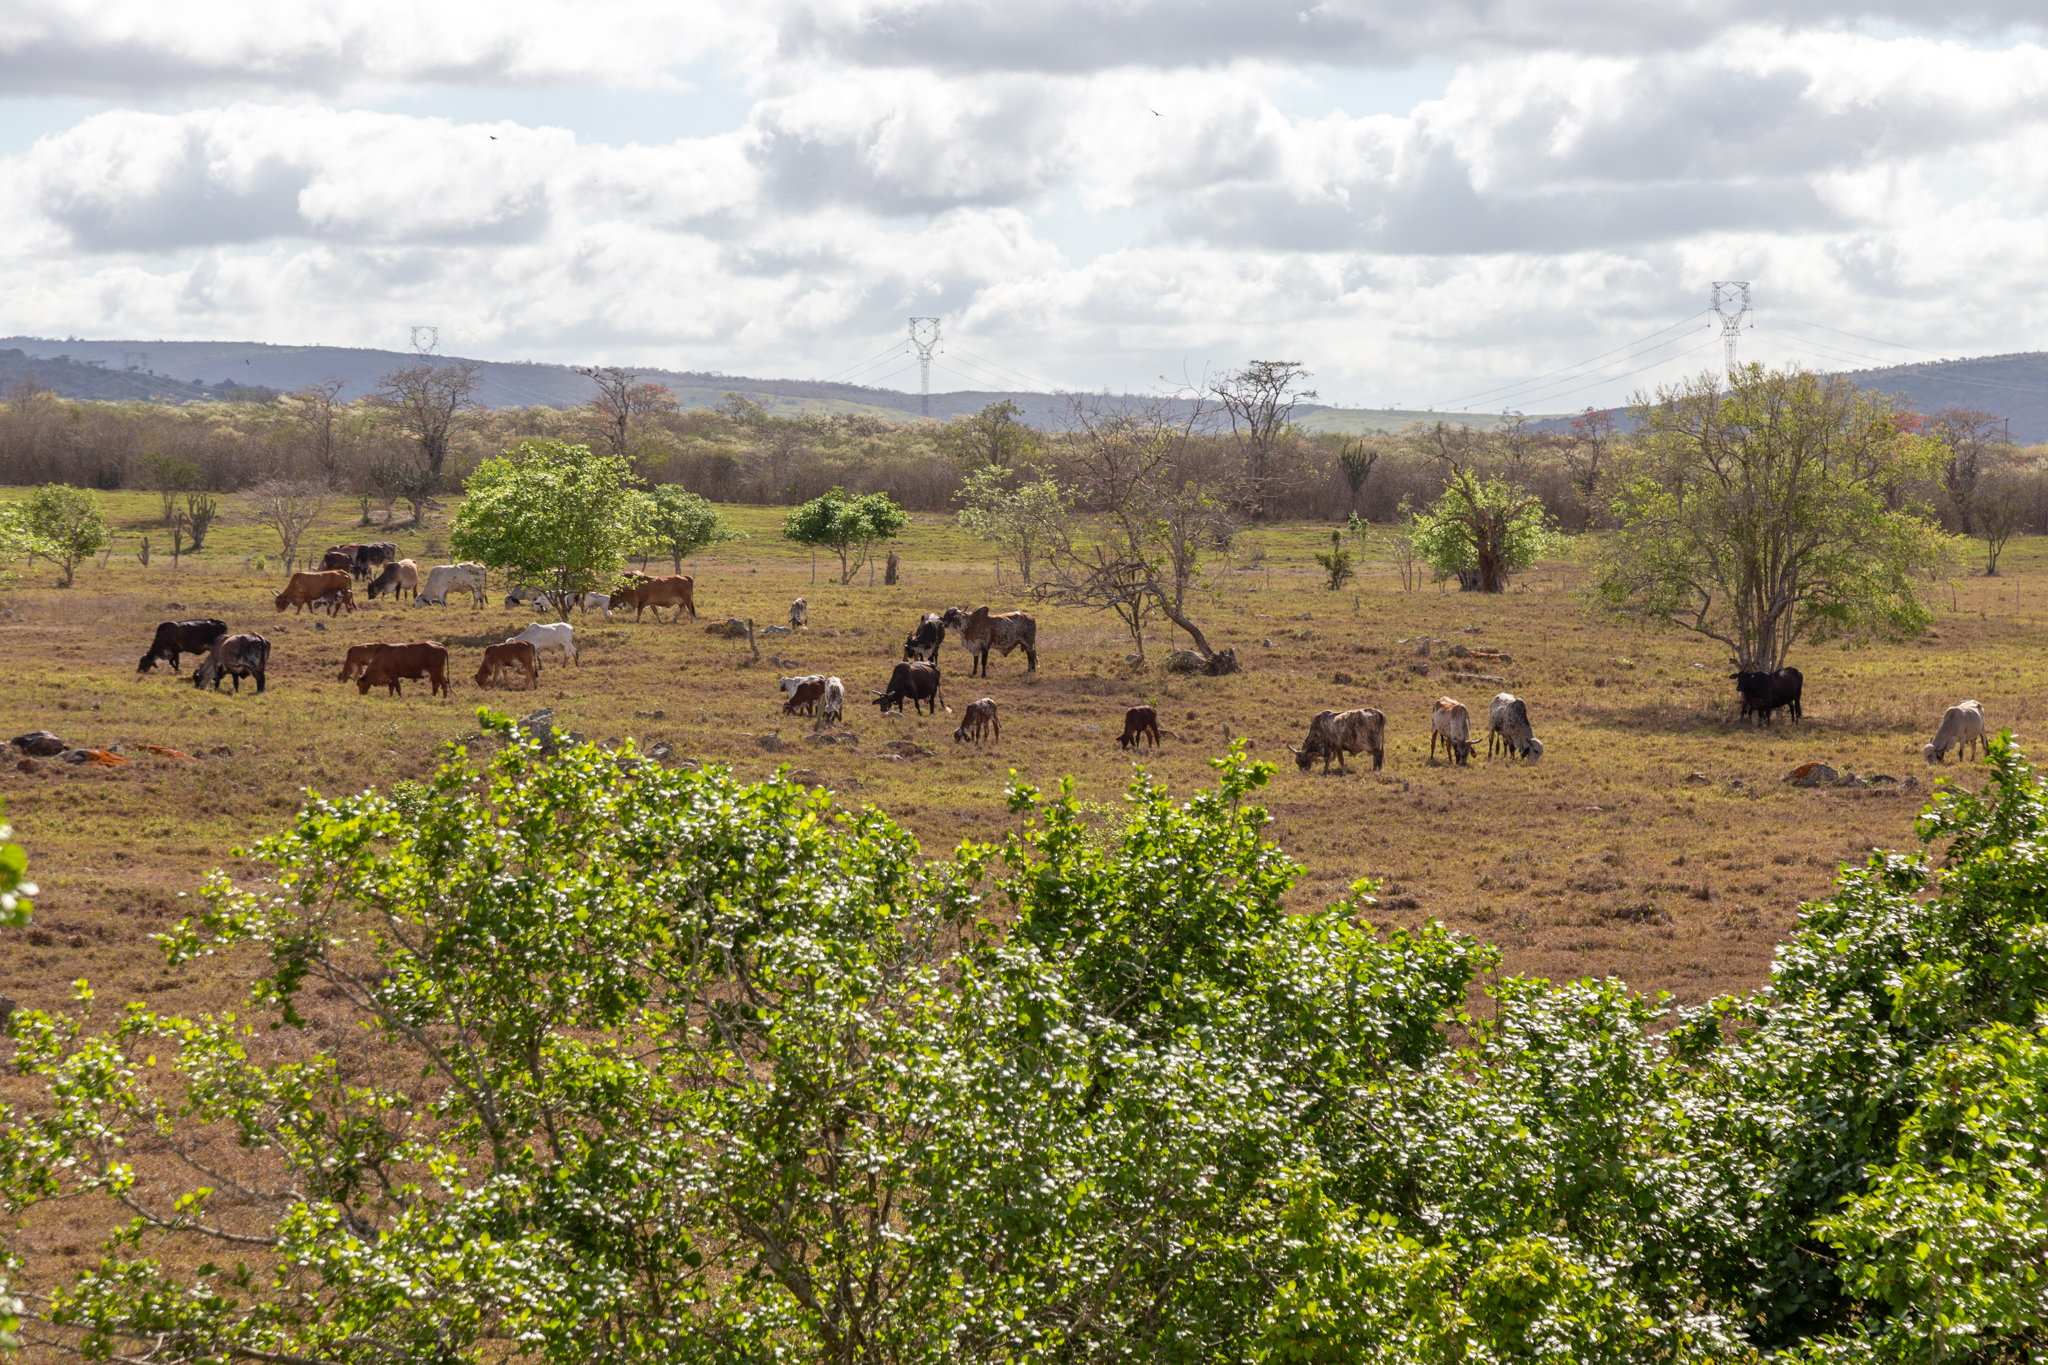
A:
449 440 647 618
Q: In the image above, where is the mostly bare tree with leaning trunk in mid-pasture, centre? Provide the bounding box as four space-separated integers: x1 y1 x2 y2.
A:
1038 397 1241 657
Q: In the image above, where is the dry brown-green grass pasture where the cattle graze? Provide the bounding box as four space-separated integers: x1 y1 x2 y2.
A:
0 493 2048 1031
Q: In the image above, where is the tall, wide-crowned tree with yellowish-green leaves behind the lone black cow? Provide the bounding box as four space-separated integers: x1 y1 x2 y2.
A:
1597 364 1952 671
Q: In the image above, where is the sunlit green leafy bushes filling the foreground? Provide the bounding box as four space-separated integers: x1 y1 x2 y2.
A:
0 732 2048 1365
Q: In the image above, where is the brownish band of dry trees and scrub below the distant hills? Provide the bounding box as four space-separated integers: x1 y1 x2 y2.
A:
0 362 2048 534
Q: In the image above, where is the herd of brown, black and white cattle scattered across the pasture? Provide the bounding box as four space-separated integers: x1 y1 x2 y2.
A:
123 542 1985 774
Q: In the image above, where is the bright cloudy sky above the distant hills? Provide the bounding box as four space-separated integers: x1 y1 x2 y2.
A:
0 0 2048 413
